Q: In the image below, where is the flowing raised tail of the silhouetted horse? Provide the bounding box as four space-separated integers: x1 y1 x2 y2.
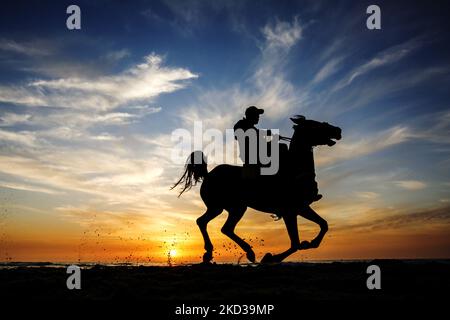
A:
171 151 208 197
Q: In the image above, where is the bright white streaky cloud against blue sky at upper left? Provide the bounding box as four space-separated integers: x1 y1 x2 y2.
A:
0 54 198 111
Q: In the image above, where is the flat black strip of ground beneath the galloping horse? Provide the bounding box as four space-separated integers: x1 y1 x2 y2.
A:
0 260 450 303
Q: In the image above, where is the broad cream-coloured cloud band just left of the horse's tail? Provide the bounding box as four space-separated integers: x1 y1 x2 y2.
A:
0 151 170 210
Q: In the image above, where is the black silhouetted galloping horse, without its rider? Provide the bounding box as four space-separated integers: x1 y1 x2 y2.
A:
174 116 341 263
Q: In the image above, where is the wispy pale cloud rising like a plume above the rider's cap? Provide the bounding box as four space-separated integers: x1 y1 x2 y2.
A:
180 18 305 129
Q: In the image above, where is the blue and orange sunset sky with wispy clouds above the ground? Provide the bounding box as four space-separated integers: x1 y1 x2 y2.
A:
0 0 450 263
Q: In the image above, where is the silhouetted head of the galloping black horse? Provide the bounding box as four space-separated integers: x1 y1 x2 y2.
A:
291 116 342 147
